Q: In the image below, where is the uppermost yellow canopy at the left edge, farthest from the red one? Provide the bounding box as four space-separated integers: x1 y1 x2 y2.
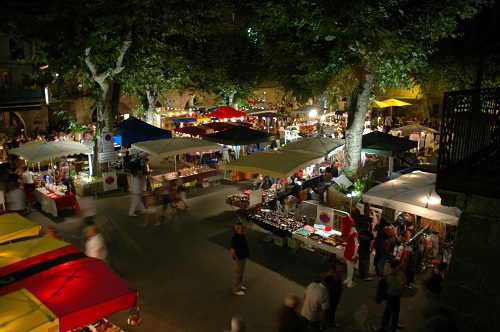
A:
0 213 41 243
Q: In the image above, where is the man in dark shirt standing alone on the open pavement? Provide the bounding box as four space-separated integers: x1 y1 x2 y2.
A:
231 221 250 296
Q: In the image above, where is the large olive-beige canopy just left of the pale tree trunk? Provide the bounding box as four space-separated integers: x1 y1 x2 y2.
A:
226 150 324 179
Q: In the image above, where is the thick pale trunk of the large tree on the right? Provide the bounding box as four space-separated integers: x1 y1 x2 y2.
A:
344 72 373 180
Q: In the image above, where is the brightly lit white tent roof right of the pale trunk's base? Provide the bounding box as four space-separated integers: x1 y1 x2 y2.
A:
363 171 461 225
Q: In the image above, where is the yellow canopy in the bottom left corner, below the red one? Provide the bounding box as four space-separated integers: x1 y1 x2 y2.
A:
0 289 60 332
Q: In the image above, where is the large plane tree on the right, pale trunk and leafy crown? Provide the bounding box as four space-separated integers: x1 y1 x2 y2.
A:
248 0 487 178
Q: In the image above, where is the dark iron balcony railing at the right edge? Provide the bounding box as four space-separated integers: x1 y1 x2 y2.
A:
436 88 500 198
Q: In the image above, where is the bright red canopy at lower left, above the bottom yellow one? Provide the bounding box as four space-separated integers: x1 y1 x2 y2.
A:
26 258 137 331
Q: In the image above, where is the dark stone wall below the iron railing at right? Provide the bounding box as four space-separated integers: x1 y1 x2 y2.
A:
442 196 500 331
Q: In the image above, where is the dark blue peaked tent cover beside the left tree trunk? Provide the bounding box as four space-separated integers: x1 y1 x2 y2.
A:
113 116 172 145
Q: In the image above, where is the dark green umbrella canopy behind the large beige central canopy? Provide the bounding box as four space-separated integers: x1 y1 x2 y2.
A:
202 126 279 145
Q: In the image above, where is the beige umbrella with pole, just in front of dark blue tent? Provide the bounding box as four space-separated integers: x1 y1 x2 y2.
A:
132 137 219 169
